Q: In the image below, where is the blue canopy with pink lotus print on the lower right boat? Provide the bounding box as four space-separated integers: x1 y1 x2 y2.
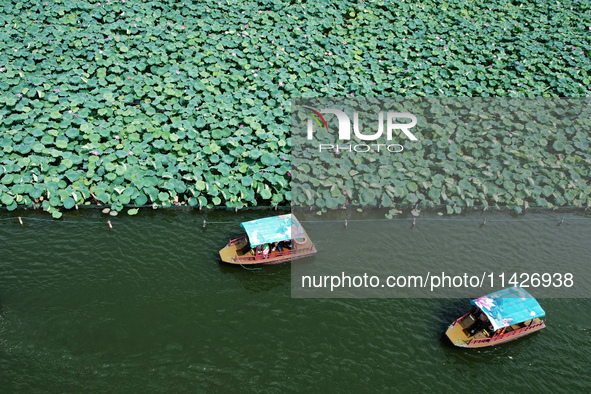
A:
472 286 546 331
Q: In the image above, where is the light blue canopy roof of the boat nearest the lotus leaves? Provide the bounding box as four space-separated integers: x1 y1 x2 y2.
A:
241 214 305 247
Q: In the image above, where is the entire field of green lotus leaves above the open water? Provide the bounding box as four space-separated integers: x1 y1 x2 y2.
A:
0 0 591 216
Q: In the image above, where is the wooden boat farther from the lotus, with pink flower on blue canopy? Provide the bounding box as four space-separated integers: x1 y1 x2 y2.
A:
446 286 546 348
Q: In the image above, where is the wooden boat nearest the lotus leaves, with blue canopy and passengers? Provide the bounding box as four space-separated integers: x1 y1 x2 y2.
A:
220 214 316 265
